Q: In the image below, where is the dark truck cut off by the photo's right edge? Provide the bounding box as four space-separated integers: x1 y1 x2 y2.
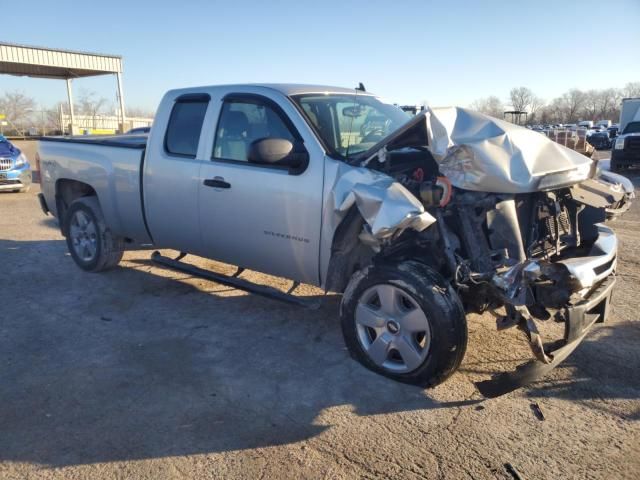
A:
611 98 640 172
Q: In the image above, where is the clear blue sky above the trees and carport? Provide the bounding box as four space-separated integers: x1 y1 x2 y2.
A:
0 0 640 110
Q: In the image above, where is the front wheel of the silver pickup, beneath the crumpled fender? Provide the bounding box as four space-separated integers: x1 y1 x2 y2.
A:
340 262 467 387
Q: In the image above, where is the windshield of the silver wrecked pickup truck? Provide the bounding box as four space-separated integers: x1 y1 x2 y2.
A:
293 93 412 158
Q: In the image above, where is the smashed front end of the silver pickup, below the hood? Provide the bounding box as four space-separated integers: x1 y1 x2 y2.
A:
439 188 617 397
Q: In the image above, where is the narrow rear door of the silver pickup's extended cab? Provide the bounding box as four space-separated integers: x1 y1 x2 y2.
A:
143 93 210 252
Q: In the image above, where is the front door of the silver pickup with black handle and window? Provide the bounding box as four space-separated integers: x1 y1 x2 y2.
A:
198 93 324 284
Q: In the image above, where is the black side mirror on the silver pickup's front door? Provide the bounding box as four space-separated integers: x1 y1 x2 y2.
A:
248 138 309 175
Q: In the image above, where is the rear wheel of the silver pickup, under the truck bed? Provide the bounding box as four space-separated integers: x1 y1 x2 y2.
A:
64 197 124 272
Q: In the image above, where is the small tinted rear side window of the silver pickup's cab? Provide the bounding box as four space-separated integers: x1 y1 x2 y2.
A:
164 99 209 158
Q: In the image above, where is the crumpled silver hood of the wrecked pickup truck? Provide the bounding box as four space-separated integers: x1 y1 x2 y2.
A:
426 107 592 193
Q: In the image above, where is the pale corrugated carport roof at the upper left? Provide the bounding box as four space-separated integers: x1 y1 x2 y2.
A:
0 42 122 79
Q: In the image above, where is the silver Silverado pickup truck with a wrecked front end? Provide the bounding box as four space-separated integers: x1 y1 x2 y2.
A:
38 85 633 396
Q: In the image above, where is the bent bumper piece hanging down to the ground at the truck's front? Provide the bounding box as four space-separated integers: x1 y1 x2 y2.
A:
476 275 616 398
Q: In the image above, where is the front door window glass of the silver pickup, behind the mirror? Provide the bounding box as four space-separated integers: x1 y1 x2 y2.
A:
213 100 295 162
